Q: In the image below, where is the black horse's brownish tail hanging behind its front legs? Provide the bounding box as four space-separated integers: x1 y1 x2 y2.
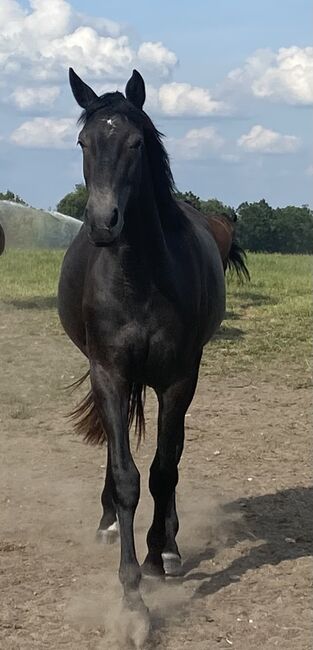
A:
68 370 146 449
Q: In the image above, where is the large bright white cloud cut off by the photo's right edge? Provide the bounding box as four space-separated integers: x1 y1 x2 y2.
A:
228 46 313 105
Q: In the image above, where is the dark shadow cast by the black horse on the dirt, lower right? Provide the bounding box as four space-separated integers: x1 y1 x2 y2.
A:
183 487 313 598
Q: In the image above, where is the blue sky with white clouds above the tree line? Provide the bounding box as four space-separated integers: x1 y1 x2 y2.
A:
0 0 313 207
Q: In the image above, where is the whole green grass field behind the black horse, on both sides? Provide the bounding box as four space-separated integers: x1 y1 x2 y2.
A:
0 250 312 372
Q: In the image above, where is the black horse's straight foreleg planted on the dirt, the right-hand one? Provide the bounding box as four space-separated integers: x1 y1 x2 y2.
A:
143 365 198 575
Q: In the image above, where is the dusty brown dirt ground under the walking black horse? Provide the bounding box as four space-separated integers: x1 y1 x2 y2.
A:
0 301 313 650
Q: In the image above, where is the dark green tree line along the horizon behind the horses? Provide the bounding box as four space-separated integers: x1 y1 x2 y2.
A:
0 183 313 253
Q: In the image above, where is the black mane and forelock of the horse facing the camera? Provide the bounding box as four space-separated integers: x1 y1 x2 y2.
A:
78 91 181 219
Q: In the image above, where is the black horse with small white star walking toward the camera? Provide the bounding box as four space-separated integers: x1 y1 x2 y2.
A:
59 69 247 606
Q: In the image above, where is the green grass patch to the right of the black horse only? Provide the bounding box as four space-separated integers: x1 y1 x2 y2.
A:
204 254 312 369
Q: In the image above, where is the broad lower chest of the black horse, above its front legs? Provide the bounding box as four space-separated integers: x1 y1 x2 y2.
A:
85 284 187 385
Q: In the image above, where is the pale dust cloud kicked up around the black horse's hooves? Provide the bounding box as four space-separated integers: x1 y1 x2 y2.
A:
65 486 239 650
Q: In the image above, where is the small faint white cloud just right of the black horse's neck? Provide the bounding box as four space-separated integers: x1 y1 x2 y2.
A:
168 126 224 160
